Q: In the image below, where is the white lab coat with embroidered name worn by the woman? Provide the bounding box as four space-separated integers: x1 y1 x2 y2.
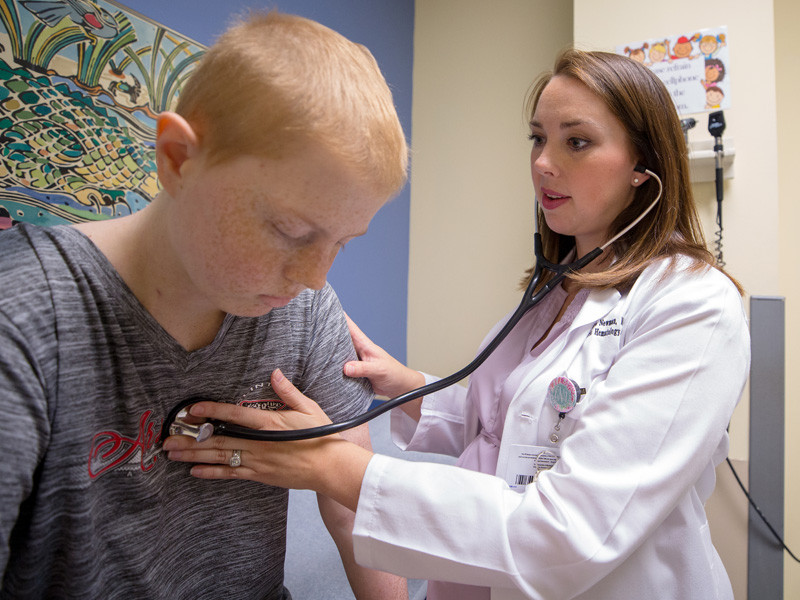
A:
353 260 750 600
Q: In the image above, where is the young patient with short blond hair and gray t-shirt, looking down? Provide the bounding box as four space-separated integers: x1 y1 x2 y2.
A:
0 13 407 599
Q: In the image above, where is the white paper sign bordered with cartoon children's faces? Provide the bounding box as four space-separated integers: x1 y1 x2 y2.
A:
616 27 731 115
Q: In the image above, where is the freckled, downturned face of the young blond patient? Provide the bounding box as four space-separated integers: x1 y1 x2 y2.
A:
169 145 386 316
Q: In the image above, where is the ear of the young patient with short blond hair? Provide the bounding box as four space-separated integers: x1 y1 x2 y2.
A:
156 112 200 196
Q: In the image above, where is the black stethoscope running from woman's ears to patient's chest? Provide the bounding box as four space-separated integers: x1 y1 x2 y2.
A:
161 165 664 442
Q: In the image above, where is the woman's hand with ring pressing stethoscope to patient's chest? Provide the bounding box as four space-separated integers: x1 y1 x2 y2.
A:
164 369 372 510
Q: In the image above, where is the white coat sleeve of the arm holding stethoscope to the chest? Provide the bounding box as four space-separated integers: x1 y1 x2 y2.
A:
354 264 750 598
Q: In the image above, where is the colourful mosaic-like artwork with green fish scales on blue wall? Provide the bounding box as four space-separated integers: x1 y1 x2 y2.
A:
0 0 205 230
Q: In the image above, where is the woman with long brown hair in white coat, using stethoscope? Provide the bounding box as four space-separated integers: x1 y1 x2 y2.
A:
165 50 749 600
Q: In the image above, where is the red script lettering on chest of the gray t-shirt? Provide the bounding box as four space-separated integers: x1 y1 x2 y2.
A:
89 410 161 479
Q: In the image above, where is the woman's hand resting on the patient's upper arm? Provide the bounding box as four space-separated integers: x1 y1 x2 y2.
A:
344 315 425 404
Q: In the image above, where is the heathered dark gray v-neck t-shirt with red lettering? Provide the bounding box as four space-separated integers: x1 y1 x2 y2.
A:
0 225 372 600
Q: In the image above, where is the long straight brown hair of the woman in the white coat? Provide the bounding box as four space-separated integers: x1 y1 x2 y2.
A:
523 48 742 292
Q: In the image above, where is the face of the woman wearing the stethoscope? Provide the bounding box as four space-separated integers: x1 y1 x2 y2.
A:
531 75 646 255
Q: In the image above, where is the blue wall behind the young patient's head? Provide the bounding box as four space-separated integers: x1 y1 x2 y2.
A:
122 0 414 362
